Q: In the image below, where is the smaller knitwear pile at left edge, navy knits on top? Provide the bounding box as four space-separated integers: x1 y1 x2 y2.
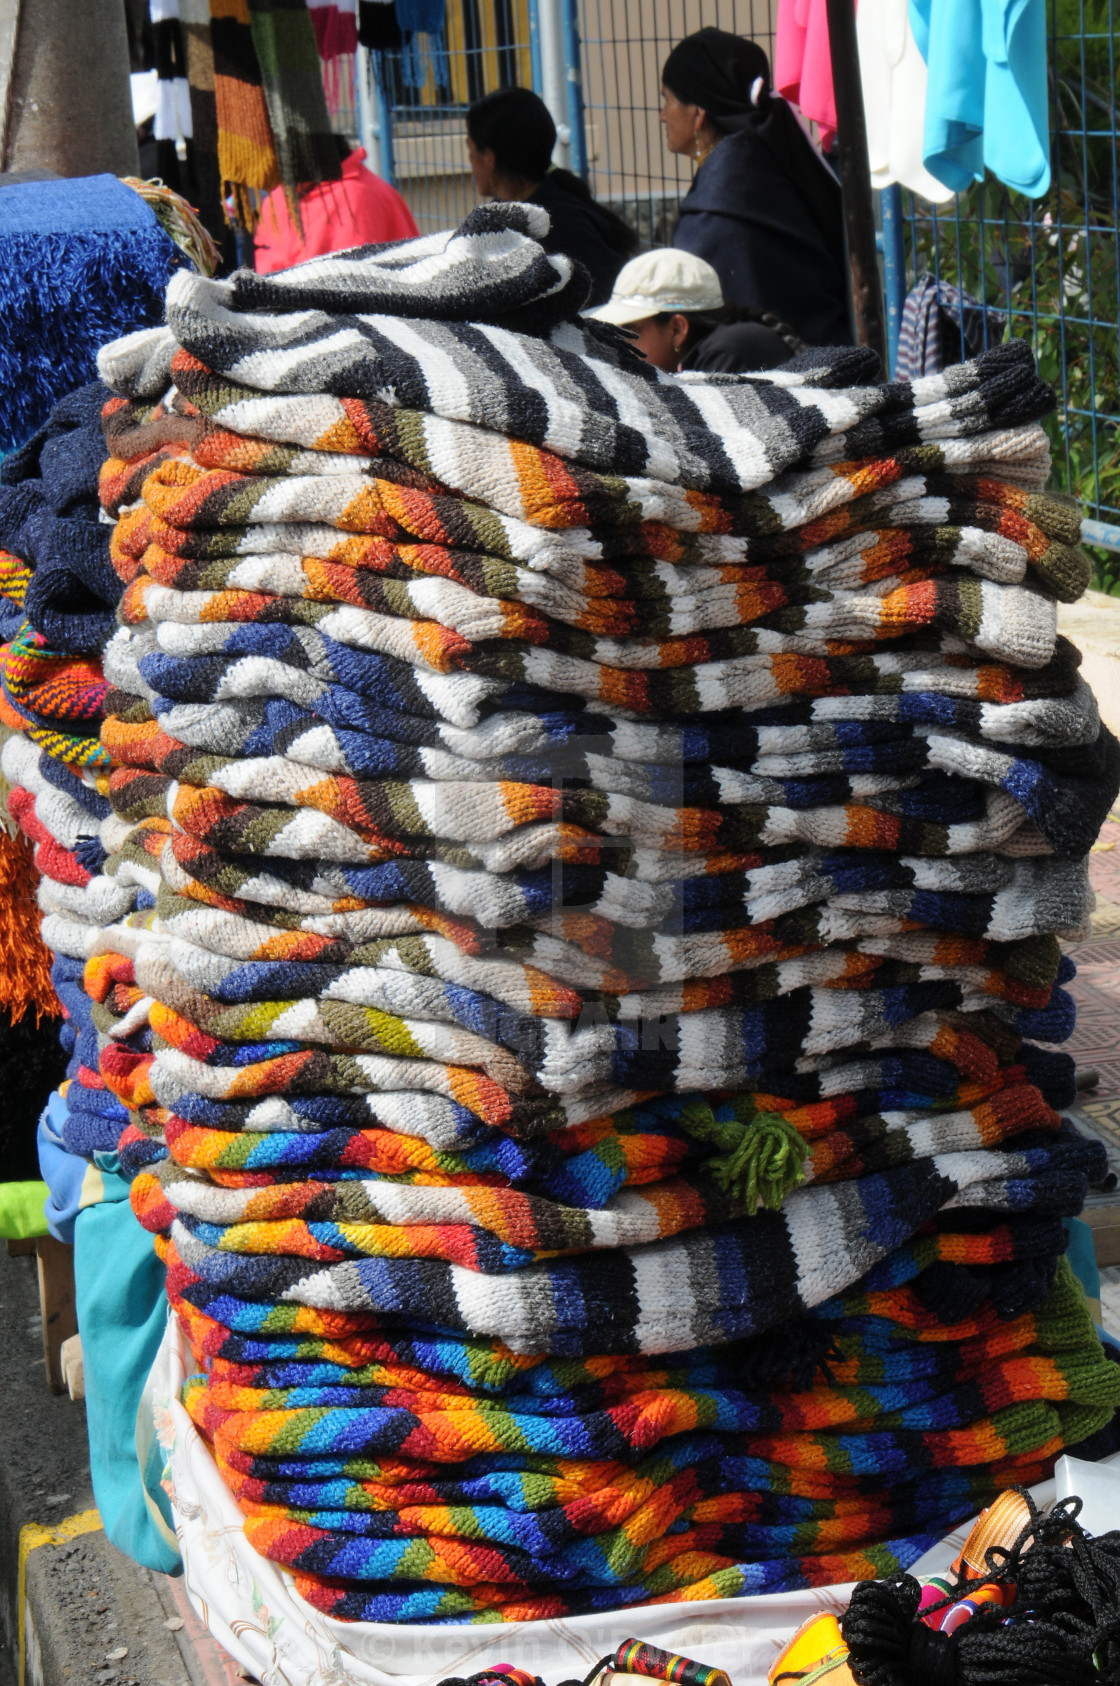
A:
0 381 147 1158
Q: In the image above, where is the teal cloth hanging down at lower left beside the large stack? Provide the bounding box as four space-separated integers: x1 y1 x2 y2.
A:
74 1200 182 1575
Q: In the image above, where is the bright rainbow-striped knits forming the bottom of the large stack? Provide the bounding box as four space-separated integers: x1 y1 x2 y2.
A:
159 1265 1108 1619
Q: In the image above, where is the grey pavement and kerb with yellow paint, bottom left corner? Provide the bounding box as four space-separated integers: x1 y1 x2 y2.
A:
0 1251 245 1686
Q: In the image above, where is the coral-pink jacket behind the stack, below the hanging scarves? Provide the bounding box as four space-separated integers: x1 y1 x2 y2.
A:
255 135 417 275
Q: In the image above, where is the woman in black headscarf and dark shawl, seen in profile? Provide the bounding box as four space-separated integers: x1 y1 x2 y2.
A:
661 29 852 346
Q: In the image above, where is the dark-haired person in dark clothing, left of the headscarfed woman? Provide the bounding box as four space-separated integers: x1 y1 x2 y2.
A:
467 88 638 305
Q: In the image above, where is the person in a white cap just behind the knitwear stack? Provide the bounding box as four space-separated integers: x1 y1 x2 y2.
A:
587 246 801 374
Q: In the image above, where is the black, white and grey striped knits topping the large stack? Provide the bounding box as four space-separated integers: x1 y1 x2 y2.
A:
109 283 1053 492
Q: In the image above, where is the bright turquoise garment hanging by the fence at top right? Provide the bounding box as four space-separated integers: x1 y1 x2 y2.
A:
909 0 1051 199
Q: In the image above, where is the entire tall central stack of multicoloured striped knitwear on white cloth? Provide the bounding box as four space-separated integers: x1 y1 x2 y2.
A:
91 206 1120 1620
